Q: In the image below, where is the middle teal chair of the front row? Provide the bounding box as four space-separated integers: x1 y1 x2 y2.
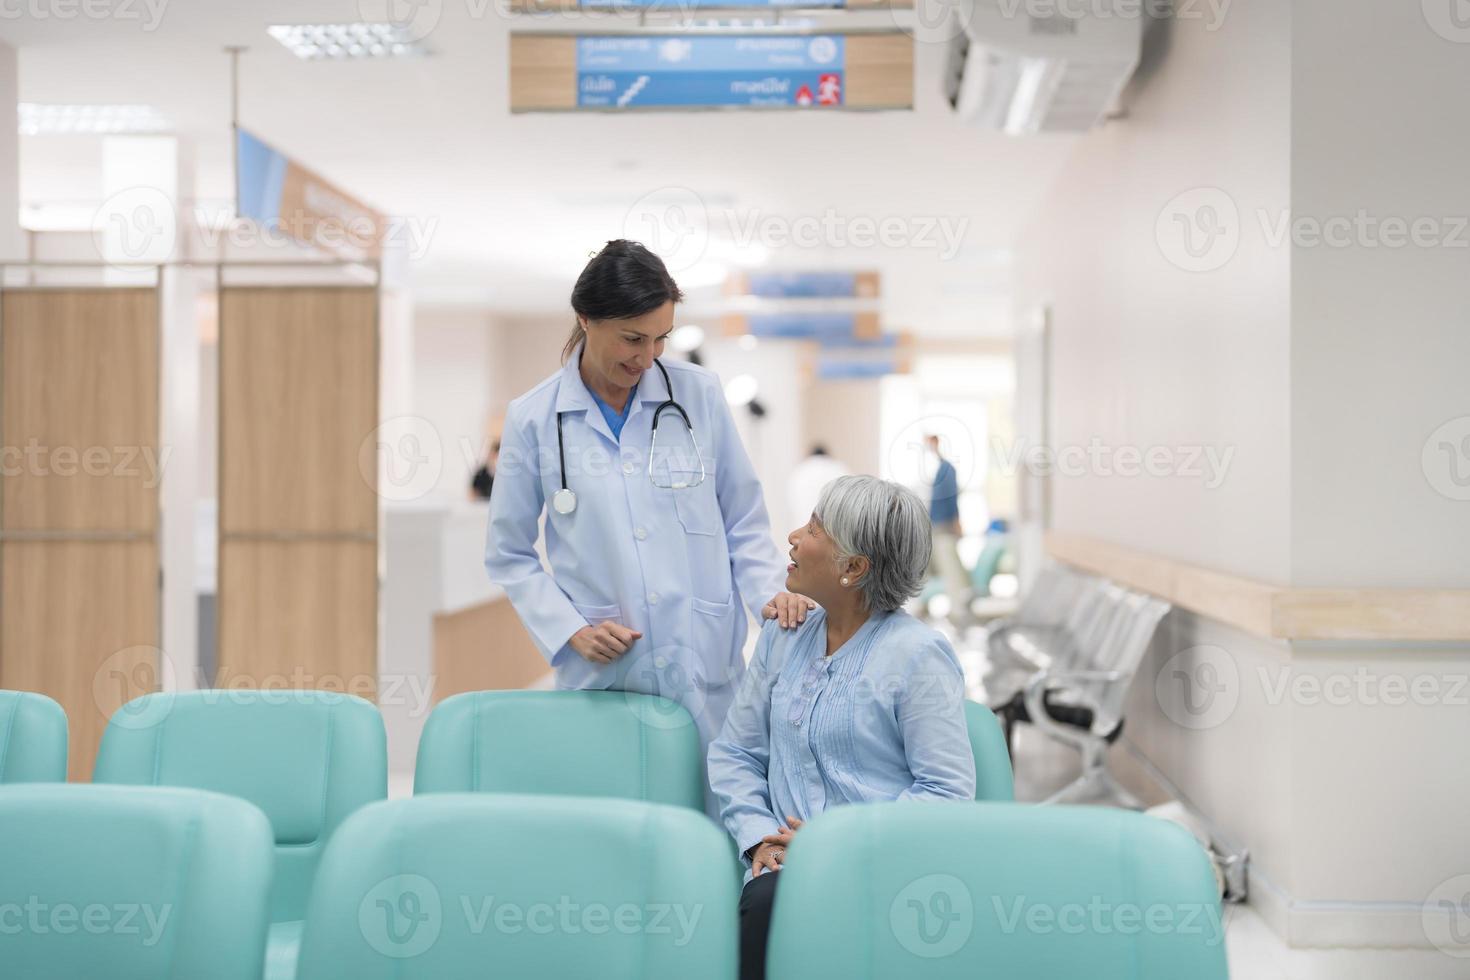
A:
297 793 736 980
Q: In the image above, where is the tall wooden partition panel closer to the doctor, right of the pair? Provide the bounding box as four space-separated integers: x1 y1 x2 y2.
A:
215 287 378 696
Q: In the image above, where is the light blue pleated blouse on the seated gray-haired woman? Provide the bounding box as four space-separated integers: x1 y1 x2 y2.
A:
709 610 975 865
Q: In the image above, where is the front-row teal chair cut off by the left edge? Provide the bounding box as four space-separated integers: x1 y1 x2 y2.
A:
0 783 270 980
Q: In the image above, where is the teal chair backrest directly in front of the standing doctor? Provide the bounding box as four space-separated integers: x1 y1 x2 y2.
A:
413 691 704 810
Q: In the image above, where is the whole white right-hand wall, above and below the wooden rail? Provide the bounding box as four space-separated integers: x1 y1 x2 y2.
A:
1016 0 1470 952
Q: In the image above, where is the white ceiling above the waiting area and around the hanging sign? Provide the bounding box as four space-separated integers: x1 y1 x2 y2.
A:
0 0 1072 334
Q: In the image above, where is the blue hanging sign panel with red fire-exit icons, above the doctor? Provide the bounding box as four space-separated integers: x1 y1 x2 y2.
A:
576 34 845 109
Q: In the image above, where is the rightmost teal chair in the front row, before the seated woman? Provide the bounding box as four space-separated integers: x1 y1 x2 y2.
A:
766 802 1227 980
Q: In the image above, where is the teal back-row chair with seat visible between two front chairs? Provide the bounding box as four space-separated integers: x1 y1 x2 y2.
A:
93 689 388 980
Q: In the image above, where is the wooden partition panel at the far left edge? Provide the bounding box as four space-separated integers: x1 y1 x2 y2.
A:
0 289 166 780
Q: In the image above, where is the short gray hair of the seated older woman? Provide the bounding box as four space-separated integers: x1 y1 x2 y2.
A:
813 476 933 613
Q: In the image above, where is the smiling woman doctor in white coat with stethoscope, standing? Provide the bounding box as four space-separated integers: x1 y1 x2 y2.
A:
485 239 814 790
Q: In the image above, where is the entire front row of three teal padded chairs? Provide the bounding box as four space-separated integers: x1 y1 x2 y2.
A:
0 785 1227 980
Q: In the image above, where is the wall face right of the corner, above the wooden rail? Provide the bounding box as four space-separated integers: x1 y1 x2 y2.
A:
1291 0 1470 588
